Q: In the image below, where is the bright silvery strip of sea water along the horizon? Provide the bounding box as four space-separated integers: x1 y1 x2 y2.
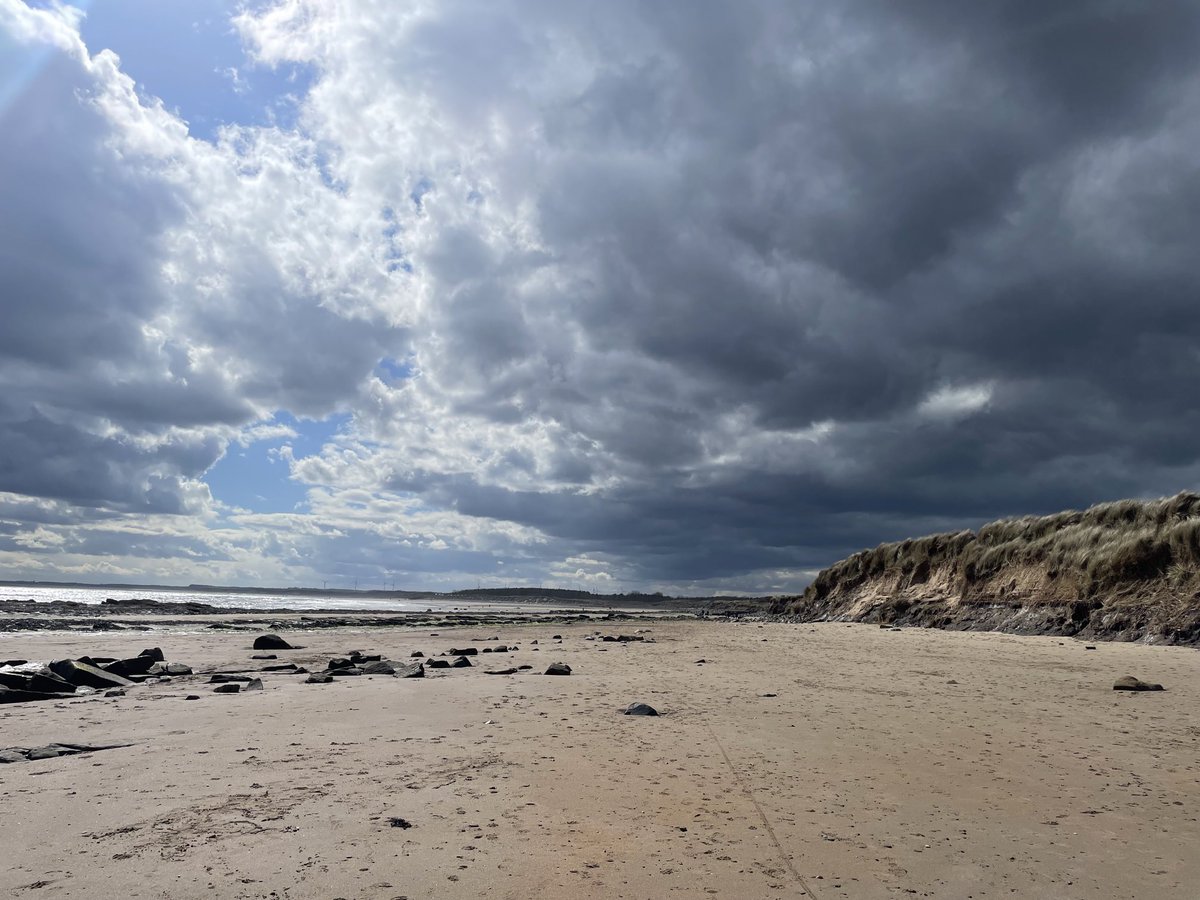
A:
0 584 563 612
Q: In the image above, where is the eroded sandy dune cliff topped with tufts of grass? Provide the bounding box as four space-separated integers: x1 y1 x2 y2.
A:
774 493 1200 644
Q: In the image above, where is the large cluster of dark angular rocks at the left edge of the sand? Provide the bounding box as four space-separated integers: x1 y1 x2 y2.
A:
0 647 192 703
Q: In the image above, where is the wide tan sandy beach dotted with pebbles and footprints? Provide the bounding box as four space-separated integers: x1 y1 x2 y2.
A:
0 620 1200 900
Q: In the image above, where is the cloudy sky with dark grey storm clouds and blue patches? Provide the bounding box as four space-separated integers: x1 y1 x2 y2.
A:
0 0 1200 594
